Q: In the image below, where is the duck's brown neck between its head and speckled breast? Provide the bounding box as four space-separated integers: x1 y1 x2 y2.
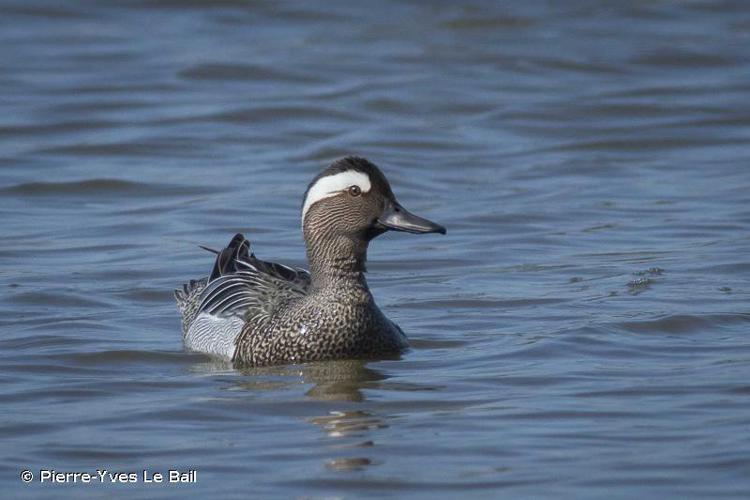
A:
305 230 374 290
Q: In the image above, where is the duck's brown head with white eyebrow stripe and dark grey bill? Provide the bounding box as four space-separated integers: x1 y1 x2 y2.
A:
302 156 445 248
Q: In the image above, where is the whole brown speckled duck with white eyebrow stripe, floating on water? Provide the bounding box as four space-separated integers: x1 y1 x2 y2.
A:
174 156 446 367
